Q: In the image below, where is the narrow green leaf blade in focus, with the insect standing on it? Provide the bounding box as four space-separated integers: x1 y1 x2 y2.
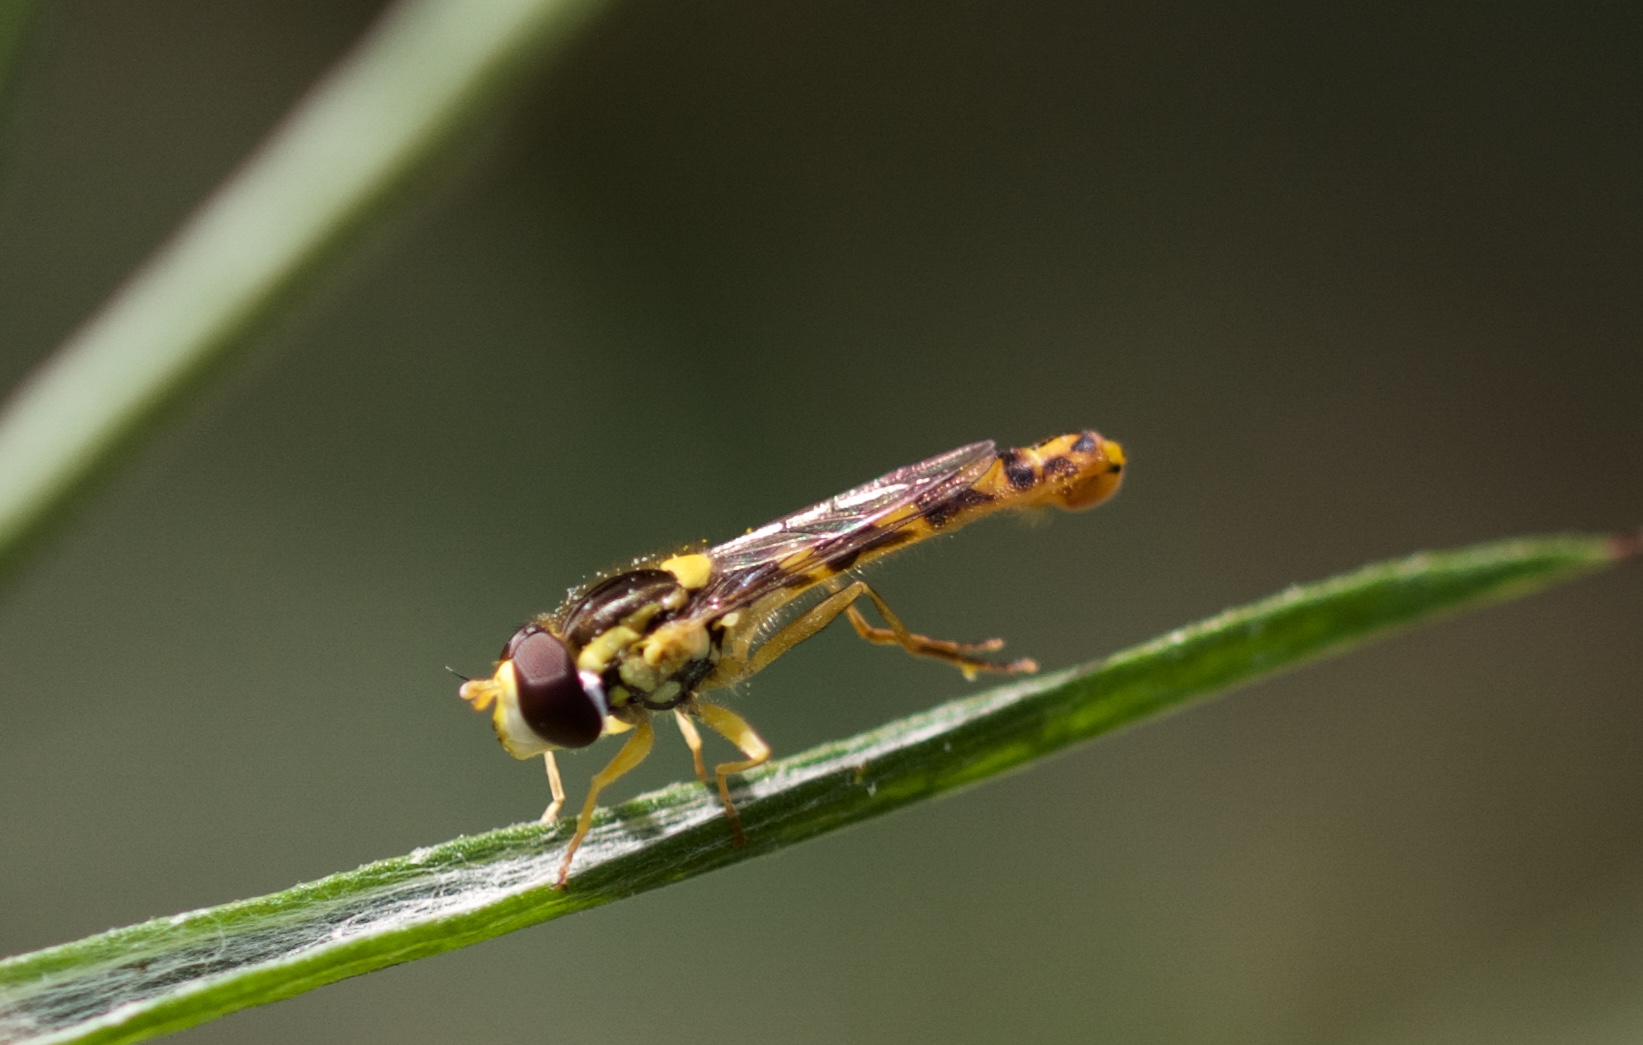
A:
0 536 1638 1045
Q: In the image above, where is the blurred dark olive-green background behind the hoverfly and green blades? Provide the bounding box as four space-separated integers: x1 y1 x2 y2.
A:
0 0 1643 1045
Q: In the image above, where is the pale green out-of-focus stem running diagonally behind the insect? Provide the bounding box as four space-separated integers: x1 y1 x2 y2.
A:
0 0 600 572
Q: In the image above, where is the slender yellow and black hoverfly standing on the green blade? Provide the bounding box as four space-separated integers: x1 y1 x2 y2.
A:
462 430 1124 887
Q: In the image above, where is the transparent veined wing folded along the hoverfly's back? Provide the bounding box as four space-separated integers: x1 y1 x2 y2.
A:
697 440 997 615
